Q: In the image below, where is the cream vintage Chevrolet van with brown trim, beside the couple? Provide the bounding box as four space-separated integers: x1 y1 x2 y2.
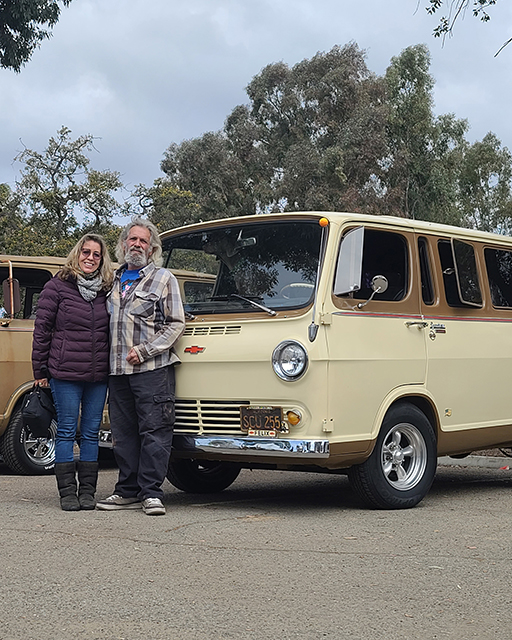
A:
154 212 512 508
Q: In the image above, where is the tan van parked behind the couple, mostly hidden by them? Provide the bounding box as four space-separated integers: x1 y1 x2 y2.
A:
0 255 215 474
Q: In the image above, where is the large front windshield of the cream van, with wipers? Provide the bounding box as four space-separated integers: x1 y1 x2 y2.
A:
163 220 322 314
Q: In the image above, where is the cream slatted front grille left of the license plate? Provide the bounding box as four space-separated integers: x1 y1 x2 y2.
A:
174 399 250 433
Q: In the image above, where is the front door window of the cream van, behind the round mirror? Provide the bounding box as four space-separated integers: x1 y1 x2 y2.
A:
353 228 409 301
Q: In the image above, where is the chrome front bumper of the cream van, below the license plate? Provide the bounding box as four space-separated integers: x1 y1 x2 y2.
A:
100 430 329 460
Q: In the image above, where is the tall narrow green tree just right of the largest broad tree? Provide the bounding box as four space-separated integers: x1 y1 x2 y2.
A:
383 45 468 224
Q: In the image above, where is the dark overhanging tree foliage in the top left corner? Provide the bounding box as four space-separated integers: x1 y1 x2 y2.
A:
0 0 71 73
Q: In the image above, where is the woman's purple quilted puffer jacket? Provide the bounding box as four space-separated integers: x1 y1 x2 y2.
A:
32 276 109 382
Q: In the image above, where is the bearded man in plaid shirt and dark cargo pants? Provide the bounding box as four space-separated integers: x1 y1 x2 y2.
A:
97 217 185 515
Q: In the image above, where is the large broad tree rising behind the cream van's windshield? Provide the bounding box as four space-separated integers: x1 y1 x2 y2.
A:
162 43 386 218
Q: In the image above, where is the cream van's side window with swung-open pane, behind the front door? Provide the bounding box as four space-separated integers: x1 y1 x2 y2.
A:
438 240 482 307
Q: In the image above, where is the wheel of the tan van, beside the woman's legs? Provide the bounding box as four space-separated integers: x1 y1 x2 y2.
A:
0 407 57 476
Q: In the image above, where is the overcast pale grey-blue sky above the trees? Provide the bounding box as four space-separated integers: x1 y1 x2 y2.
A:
0 0 512 202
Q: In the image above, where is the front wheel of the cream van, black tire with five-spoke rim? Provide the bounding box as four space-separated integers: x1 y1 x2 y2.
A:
349 403 437 509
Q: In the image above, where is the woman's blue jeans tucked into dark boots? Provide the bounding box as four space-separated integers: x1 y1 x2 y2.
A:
50 378 107 462
